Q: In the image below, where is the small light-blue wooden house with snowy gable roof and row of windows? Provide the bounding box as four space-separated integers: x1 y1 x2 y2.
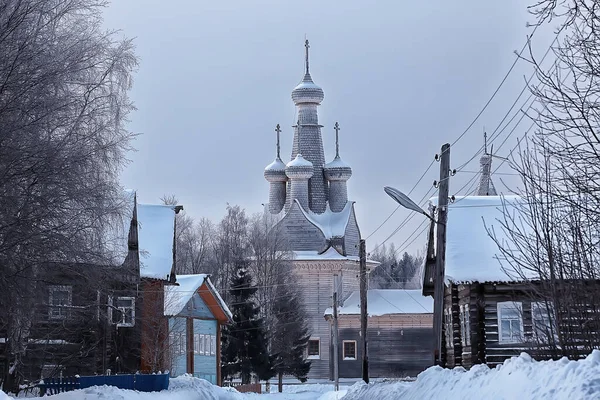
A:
164 274 233 385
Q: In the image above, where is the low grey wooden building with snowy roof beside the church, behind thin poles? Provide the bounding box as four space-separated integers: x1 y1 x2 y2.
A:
325 289 433 378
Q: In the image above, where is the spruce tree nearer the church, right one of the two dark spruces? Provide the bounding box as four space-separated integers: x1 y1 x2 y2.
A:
271 282 311 392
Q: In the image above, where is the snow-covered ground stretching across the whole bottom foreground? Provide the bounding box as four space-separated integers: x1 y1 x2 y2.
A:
0 350 600 400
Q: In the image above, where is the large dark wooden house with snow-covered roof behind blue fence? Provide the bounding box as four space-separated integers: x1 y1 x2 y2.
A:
0 192 181 388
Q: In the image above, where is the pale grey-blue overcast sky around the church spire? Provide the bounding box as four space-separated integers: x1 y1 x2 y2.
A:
105 0 554 252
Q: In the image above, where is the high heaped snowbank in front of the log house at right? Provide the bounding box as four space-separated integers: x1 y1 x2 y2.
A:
344 350 600 400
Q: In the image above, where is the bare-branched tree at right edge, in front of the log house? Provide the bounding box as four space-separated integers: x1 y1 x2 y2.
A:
490 0 600 357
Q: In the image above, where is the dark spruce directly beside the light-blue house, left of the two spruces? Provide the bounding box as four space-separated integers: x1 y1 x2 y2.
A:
222 261 274 384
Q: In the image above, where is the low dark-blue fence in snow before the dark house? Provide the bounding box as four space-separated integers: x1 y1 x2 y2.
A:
38 374 169 396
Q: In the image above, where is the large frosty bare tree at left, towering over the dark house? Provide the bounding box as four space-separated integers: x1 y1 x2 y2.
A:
0 0 137 387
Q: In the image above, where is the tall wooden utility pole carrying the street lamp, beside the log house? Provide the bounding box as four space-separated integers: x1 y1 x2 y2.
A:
433 143 450 365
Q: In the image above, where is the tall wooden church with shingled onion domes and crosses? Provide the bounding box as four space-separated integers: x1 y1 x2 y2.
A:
264 41 376 379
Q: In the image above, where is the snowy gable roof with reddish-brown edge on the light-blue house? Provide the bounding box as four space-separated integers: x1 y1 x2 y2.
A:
164 274 233 322
